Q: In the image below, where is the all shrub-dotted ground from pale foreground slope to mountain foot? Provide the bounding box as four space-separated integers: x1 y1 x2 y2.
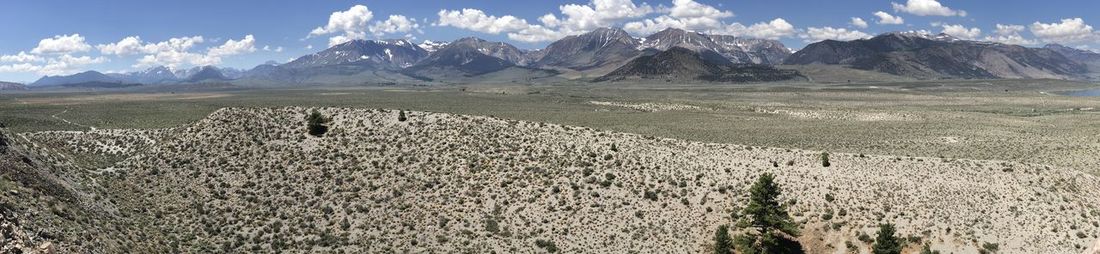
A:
0 80 1100 253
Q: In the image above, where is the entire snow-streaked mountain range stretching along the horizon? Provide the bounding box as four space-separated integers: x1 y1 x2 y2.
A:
30 27 1100 87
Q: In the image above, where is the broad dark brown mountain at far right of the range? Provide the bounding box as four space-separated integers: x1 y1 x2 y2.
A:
784 33 1087 79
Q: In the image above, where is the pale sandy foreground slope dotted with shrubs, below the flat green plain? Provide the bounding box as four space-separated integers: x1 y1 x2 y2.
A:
4 108 1100 253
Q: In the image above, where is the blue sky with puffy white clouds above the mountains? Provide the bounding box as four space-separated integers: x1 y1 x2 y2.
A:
0 0 1100 82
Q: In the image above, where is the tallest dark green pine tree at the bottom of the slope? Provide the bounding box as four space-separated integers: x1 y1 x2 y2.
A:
737 173 801 253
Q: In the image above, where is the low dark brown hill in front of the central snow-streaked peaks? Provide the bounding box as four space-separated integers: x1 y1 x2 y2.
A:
596 46 801 82
